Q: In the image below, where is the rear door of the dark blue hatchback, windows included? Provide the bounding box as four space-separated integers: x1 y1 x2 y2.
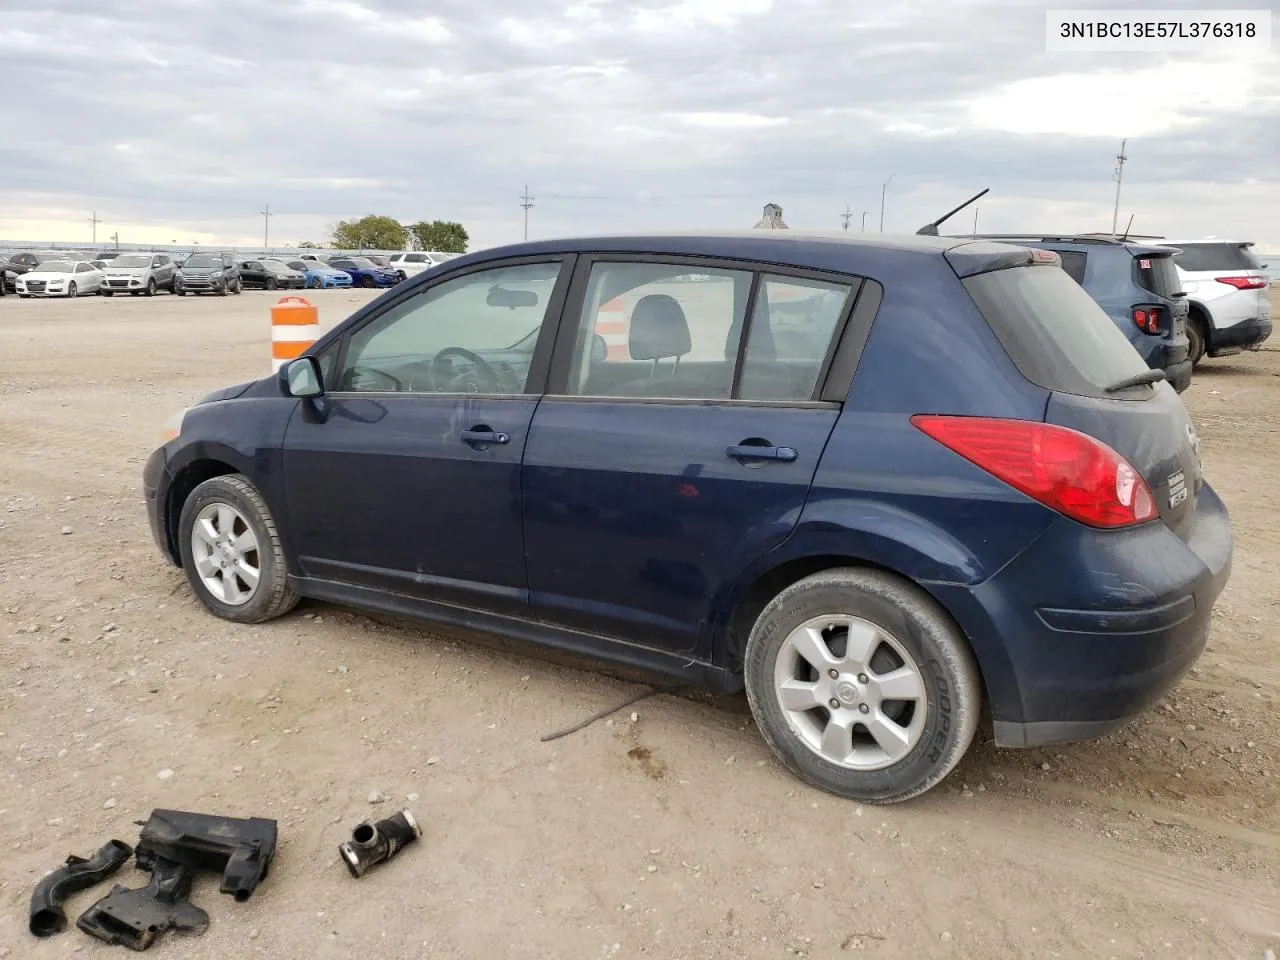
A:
524 257 858 657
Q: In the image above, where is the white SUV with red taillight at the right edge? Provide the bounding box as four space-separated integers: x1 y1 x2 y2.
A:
1161 238 1271 364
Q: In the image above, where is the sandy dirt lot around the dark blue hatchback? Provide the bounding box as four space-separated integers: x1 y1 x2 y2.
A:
0 291 1280 959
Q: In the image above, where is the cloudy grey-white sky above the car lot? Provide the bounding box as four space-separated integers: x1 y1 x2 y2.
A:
0 0 1280 251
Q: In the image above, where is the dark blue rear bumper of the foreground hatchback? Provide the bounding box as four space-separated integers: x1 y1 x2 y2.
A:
933 484 1233 746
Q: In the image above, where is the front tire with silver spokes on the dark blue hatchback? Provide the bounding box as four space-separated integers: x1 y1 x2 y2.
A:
178 474 298 623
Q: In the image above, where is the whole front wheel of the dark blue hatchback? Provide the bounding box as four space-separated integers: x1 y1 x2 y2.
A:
178 474 298 623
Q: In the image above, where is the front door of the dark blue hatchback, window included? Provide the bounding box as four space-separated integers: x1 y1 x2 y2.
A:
284 256 570 613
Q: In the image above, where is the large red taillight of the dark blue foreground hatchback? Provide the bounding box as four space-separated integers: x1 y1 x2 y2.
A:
911 415 1158 527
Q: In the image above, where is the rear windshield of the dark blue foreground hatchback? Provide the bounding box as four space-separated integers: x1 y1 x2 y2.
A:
964 266 1147 397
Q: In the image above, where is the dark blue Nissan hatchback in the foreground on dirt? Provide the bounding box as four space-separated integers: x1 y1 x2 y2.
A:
145 232 1231 803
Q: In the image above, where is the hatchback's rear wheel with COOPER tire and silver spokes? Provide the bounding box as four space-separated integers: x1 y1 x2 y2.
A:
745 568 982 804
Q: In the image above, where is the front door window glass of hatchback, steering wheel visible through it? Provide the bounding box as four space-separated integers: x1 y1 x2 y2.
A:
337 262 561 394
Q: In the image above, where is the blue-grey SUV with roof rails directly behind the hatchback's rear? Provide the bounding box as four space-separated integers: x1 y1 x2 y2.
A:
979 234 1192 393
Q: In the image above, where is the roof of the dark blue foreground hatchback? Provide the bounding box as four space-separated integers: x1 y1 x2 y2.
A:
463 229 1027 276
